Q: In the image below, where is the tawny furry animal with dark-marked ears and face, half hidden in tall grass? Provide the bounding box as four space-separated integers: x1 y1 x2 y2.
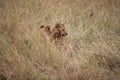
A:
41 23 73 53
